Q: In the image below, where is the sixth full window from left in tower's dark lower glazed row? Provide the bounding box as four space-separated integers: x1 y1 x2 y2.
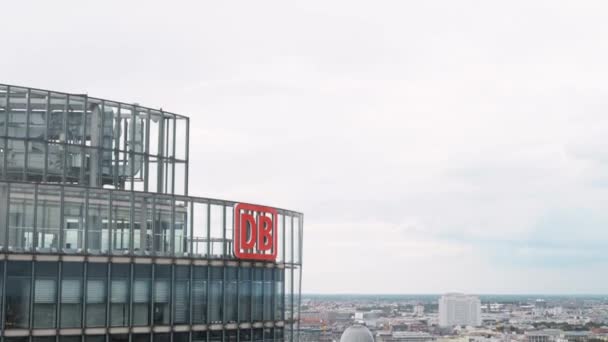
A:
132 264 152 325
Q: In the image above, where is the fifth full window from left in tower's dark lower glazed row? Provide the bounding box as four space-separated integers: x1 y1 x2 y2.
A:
110 264 131 327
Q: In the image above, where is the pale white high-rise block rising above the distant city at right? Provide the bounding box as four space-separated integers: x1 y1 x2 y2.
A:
439 293 481 327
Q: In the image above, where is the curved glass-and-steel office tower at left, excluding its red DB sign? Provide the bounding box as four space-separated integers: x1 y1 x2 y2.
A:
0 85 303 342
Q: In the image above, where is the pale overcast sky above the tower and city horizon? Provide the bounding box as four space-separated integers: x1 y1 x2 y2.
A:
0 0 608 293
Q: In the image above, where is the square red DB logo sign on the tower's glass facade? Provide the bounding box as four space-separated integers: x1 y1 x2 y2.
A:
234 203 278 261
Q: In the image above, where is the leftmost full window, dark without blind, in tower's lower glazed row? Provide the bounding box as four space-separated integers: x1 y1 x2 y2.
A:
5 261 32 329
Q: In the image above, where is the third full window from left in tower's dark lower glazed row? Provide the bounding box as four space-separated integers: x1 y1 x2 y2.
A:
60 262 83 328
